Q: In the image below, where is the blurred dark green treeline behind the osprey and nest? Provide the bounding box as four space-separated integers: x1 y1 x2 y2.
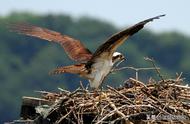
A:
0 13 190 122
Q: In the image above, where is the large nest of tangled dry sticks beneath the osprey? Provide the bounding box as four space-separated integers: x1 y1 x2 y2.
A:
9 78 190 124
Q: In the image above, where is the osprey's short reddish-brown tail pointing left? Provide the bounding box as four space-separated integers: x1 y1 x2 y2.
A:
50 64 85 75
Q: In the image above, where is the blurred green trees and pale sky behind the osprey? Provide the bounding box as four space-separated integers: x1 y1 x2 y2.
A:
0 0 190 123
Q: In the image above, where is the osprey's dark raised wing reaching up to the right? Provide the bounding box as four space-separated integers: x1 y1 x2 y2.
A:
91 15 165 61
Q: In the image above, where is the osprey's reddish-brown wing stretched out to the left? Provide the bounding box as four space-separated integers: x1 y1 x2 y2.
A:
9 23 92 62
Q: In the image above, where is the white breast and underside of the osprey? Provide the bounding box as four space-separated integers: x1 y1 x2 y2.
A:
89 59 113 88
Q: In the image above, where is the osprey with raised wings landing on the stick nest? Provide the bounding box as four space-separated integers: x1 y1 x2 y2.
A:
11 15 165 88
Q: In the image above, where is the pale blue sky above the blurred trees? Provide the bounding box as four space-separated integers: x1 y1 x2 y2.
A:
0 0 190 35
